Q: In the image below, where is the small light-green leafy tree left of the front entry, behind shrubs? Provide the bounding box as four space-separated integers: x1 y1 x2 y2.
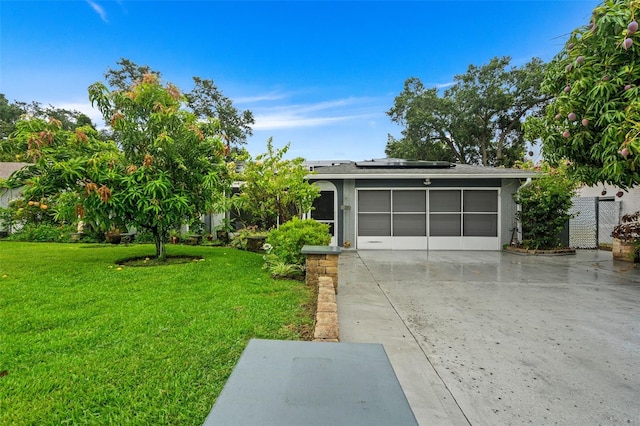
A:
235 138 320 229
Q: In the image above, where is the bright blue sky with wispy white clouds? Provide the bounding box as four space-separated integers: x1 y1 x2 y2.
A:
0 0 599 160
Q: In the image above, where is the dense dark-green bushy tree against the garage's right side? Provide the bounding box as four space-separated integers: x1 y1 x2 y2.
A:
514 163 578 250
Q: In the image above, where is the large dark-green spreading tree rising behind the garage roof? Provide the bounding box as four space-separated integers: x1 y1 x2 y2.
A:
385 57 549 166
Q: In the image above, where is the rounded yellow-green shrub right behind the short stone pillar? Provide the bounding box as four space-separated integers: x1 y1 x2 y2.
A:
266 218 331 265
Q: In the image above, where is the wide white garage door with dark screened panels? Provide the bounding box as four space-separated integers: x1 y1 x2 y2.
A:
357 189 500 250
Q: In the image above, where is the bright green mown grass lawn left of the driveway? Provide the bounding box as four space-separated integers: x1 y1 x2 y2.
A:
0 242 314 425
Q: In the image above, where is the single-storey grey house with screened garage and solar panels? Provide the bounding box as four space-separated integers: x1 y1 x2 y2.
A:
308 158 536 250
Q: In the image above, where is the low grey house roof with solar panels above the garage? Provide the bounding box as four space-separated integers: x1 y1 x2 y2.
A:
310 158 539 179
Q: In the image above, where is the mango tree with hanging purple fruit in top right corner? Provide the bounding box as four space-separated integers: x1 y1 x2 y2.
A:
527 0 640 188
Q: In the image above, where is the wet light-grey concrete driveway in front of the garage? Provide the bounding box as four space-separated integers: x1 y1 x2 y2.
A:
338 251 640 425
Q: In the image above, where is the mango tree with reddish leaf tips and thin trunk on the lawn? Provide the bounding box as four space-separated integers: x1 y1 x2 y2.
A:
85 74 227 259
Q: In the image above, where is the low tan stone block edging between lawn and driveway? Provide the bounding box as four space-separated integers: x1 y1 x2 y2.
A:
313 276 340 342
